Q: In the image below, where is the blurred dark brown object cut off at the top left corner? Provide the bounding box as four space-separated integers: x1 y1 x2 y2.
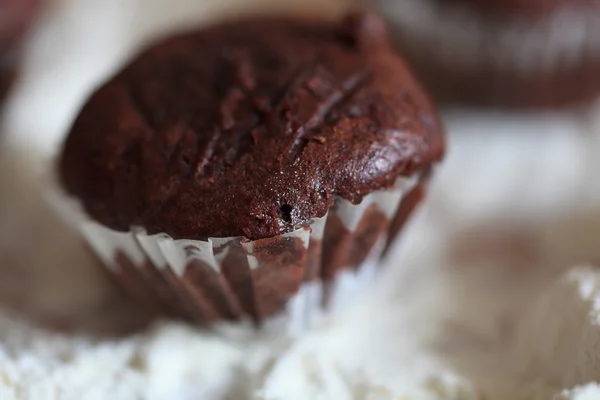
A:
0 0 41 102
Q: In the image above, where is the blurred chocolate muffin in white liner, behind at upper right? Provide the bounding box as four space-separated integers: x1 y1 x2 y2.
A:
365 0 600 108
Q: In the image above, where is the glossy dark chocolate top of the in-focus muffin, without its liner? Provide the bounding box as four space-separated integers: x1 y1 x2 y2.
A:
59 13 444 240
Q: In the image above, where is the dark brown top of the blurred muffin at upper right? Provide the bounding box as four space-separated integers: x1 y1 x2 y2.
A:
450 0 598 16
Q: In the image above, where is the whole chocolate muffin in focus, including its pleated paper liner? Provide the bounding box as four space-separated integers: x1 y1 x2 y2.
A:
59 13 444 324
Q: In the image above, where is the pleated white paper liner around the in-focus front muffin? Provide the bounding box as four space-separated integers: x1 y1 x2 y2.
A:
49 176 422 330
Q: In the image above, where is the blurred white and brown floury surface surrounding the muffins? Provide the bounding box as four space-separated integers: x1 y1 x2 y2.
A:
0 0 600 400
